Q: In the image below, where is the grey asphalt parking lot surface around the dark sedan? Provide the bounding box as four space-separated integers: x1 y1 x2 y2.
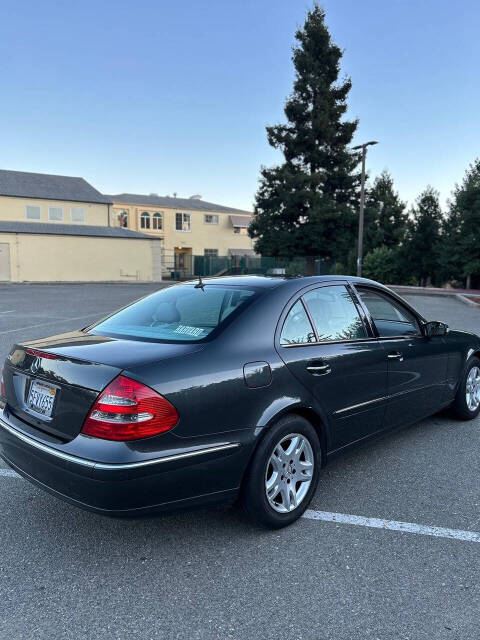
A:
0 285 480 640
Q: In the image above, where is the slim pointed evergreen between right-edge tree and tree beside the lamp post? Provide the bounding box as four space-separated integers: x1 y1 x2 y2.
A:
402 186 442 287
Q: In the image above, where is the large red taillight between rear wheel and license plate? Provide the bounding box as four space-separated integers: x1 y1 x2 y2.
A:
82 376 178 440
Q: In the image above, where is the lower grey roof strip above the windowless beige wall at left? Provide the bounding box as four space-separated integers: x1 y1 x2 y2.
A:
0 220 155 240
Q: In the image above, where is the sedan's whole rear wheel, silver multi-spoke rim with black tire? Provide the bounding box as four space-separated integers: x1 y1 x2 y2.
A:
241 415 321 529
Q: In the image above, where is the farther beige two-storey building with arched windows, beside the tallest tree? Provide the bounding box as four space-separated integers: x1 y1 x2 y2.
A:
108 193 254 273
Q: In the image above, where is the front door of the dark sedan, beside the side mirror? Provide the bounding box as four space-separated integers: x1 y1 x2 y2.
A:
355 286 448 427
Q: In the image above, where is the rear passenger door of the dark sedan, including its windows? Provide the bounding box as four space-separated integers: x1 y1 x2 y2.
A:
276 281 387 450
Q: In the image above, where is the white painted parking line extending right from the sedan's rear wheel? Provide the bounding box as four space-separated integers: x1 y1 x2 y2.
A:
303 509 480 542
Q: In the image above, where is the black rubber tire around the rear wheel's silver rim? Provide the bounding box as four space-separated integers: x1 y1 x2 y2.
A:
240 414 322 529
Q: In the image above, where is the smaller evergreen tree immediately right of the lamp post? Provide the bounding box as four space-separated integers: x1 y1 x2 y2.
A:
364 171 407 254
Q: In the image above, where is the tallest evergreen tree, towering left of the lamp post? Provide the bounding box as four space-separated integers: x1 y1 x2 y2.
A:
249 6 359 259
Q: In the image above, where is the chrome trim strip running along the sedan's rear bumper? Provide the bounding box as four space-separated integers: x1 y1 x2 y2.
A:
0 419 241 471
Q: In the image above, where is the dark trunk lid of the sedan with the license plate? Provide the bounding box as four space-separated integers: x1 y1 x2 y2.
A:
4 331 199 441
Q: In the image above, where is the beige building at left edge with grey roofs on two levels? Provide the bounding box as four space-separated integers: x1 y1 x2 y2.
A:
0 170 161 282
